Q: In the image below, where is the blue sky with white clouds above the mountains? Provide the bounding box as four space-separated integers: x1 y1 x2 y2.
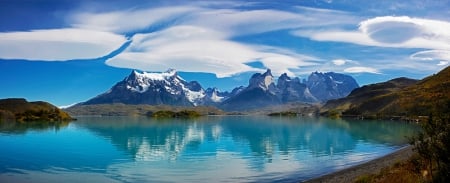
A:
0 0 450 106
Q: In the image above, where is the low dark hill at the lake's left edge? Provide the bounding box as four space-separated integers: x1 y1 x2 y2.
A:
0 98 74 122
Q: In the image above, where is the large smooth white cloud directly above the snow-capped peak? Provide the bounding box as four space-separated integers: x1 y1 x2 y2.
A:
106 26 313 77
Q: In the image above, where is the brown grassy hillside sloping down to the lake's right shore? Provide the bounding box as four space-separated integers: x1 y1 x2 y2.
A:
321 67 450 118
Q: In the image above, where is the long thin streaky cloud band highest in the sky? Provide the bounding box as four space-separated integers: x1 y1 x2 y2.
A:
71 2 355 36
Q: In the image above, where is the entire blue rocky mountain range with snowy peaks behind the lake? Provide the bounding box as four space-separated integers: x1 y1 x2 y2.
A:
77 69 359 111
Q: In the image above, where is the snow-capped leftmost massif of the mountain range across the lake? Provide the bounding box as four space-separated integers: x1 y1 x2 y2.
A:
83 69 206 106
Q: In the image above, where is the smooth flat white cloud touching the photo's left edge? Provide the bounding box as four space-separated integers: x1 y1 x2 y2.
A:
0 29 127 61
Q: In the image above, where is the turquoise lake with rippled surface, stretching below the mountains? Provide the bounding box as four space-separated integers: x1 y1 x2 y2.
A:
0 116 417 182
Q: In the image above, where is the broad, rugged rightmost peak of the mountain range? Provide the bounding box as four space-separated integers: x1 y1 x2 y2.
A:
306 72 359 101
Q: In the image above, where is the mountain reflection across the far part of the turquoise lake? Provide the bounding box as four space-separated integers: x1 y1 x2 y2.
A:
77 116 415 164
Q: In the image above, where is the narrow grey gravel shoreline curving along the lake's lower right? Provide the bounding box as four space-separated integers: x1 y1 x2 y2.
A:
302 145 414 183
